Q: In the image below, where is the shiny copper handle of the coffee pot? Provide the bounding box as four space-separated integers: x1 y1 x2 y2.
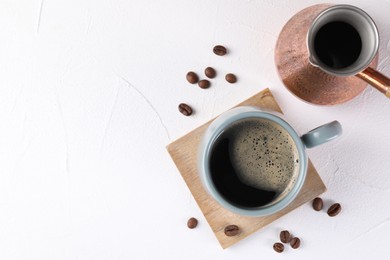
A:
356 67 390 98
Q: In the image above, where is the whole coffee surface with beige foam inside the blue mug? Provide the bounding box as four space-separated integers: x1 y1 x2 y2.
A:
209 118 299 207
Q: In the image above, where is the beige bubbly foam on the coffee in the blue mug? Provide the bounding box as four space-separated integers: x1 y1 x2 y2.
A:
224 118 299 194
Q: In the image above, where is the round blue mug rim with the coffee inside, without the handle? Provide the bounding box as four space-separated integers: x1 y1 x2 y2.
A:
202 108 307 216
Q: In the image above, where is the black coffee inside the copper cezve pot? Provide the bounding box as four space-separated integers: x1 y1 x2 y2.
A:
314 21 362 69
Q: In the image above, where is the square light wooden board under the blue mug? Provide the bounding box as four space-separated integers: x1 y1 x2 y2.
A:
167 89 326 249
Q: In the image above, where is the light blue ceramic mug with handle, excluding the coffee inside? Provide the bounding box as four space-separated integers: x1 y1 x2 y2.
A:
198 106 342 217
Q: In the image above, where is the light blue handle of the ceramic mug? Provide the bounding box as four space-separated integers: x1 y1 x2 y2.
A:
301 120 343 148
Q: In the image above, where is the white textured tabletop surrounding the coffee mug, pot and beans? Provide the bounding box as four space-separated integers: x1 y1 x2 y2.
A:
0 0 390 260
